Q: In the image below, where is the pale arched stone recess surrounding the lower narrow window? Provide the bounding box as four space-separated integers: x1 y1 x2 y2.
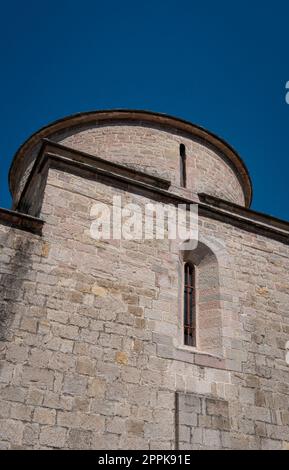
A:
178 239 226 356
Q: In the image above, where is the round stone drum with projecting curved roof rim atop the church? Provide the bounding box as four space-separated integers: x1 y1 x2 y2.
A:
10 111 251 206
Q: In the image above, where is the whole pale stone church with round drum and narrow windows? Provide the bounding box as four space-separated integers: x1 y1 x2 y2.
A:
0 110 289 450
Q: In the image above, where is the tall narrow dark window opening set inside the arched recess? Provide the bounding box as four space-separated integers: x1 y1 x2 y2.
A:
184 263 196 346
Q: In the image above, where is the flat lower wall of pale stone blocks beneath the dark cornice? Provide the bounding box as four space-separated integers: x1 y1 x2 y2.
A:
0 170 289 449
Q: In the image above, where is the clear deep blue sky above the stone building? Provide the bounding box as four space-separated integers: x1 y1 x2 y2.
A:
0 0 289 220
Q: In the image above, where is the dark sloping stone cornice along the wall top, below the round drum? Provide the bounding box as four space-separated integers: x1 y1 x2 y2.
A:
17 140 289 244
